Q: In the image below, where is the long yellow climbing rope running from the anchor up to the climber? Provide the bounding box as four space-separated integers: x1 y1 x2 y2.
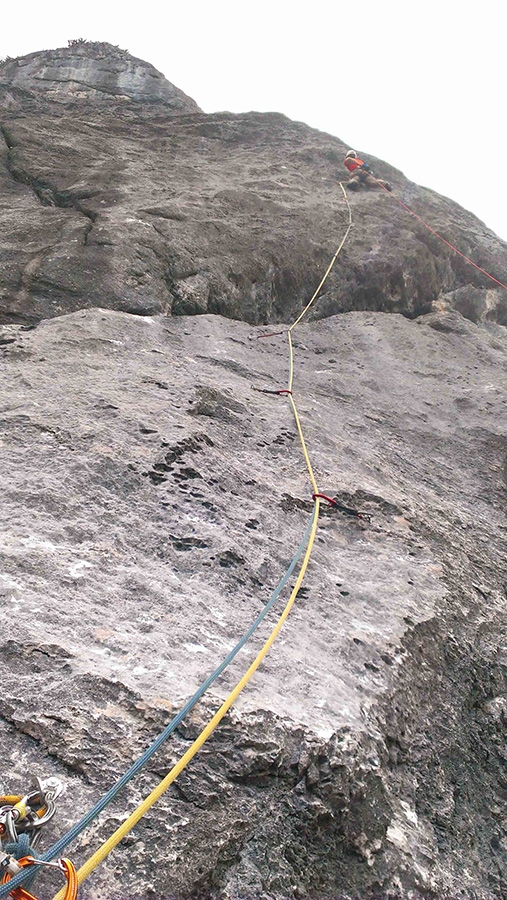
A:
54 182 352 900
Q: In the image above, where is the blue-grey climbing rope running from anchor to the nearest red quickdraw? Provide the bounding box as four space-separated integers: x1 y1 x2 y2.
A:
0 507 316 898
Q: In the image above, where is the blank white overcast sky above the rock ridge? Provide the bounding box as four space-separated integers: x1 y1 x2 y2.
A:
0 0 507 240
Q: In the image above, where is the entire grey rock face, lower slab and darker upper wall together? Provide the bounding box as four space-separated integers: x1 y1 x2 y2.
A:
0 40 507 900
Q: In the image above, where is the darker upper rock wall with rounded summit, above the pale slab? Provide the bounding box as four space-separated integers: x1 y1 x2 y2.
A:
0 44 507 324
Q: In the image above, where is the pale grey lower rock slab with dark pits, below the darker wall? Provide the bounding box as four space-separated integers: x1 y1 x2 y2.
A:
0 309 507 900
